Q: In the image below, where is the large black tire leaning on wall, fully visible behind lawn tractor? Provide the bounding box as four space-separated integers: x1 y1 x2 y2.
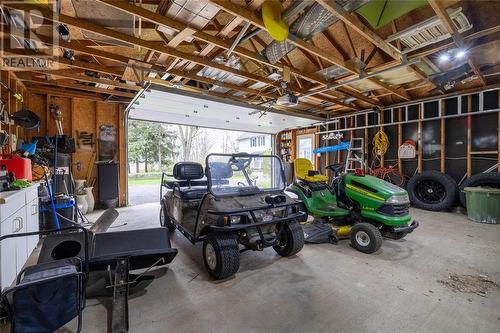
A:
406 170 458 211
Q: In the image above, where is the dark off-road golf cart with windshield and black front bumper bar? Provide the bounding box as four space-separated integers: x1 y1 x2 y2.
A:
160 153 306 279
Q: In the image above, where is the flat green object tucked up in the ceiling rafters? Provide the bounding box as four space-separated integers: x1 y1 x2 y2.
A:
356 0 427 29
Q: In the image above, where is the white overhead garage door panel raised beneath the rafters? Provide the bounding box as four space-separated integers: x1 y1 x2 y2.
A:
128 85 319 134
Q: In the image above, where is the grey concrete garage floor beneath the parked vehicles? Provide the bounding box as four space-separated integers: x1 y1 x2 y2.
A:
78 203 500 333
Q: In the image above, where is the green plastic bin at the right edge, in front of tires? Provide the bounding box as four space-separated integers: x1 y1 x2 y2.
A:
464 186 500 224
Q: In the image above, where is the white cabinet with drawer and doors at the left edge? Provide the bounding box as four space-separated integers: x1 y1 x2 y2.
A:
0 185 38 289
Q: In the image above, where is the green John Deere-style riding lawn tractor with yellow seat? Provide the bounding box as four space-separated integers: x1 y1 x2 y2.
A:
287 158 418 253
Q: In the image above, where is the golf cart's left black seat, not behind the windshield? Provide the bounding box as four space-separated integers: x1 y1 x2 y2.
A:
174 162 207 200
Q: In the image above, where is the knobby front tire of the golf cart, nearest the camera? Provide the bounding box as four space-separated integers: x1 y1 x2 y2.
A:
203 232 240 280
